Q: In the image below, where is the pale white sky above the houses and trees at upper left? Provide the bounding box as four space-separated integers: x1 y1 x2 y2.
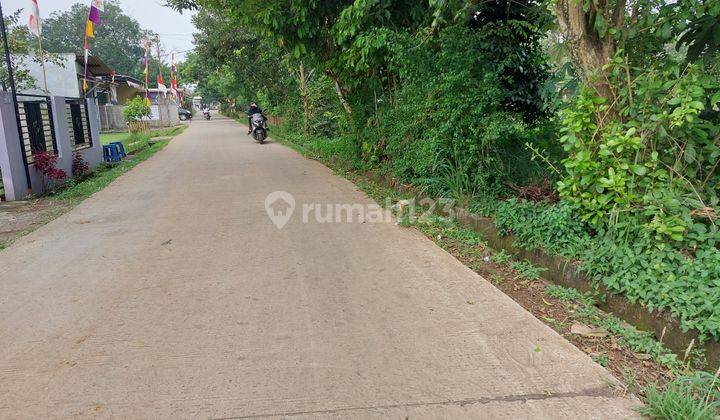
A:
0 0 195 61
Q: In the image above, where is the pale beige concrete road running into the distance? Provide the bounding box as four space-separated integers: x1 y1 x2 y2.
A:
0 114 637 419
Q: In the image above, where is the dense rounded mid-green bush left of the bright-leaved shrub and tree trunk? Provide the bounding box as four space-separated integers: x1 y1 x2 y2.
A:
382 28 556 197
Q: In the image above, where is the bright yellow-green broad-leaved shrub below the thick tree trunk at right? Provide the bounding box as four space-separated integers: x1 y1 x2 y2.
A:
558 55 720 248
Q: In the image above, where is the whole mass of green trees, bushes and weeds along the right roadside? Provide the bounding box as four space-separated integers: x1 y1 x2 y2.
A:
170 0 720 418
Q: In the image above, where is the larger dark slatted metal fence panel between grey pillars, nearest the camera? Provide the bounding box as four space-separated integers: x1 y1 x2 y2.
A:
18 94 57 164
